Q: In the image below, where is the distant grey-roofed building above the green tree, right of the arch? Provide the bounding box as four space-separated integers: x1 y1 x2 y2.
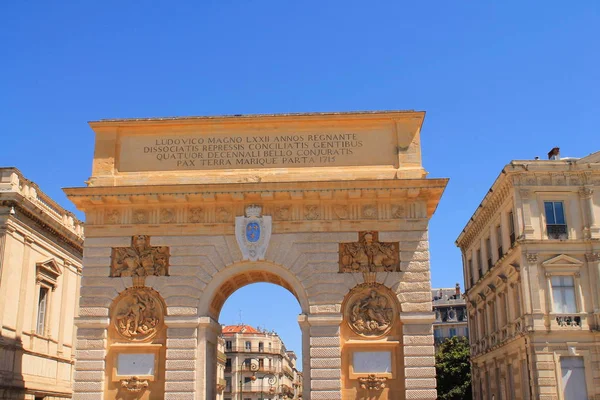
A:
431 283 469 346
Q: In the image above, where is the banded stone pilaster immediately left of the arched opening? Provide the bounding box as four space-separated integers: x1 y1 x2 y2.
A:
165 316 200 400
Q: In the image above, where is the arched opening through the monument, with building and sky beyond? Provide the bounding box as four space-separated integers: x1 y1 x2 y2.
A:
200 262 310 400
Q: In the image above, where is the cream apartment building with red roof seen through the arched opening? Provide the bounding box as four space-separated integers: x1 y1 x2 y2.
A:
222 325 302 400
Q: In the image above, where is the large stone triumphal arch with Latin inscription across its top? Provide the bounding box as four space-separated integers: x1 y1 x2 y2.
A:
66 111 447 400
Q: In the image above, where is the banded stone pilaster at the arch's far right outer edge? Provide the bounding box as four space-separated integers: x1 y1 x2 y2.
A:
400 312 437 400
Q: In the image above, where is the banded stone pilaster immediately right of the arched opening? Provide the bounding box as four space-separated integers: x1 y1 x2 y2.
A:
305 314 343 400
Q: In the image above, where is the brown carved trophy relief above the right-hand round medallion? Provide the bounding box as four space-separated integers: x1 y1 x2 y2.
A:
340 231 400 272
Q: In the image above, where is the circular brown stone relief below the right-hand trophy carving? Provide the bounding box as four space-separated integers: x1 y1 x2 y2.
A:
346 284 396 338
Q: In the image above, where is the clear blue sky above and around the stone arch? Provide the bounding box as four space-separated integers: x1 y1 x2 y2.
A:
0 0 600 362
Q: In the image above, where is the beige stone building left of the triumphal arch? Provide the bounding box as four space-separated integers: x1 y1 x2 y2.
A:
0 168 83 400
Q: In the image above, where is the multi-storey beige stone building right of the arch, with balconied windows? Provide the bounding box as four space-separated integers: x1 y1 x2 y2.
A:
457 149 600 400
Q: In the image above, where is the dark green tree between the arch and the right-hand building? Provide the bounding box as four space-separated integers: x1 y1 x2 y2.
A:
435 336 472 400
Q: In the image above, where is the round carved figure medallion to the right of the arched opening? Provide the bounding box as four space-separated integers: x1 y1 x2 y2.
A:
348 289 394 336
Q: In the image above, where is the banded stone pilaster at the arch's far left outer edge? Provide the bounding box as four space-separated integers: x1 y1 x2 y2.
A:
73 317 110 400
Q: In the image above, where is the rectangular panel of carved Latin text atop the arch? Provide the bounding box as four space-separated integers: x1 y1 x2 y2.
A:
118 129 398 172
